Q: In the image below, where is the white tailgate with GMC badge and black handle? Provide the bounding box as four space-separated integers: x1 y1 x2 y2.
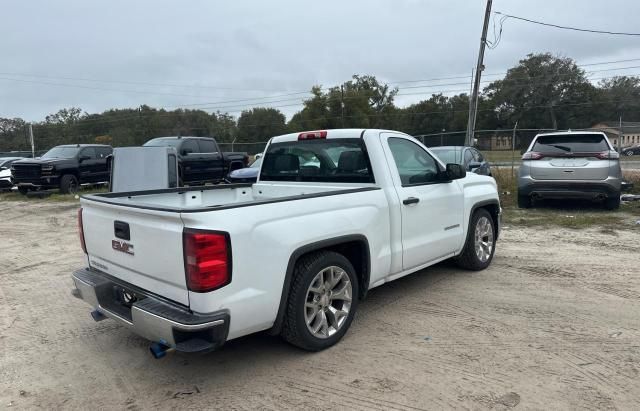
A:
81 200 189 305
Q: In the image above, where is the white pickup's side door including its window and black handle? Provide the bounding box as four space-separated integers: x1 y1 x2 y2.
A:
383 134 464 270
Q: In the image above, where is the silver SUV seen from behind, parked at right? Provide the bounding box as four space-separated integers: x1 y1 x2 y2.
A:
518 131 622 210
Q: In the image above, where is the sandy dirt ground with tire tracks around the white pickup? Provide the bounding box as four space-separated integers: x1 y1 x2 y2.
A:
0 201 640 410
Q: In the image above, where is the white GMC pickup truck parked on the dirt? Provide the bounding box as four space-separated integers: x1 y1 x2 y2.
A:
73 129 501 358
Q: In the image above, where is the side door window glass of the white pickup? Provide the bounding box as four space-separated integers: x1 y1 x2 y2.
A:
388 137 440 186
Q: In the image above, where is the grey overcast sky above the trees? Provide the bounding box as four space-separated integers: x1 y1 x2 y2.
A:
0 0 640 121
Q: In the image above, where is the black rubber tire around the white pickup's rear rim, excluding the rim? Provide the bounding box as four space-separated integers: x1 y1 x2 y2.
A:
280 251 359 351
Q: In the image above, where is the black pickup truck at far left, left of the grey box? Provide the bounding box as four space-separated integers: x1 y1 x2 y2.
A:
11 144 113 194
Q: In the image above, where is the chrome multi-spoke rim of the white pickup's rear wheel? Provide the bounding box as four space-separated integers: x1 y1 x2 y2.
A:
304 266 353 338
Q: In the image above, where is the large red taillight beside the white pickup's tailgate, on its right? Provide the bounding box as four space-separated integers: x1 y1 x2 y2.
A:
182 229 231 293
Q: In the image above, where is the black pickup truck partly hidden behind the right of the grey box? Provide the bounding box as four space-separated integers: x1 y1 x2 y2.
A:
144 137 249 185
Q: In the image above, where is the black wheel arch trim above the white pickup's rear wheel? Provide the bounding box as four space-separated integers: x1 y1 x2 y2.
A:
270 234 371 335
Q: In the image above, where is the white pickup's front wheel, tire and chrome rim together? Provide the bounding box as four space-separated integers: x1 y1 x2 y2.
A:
456 208 496 271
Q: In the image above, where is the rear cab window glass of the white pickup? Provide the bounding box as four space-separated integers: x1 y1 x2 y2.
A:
260 138 375 183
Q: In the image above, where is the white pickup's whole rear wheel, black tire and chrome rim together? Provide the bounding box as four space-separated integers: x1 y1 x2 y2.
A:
281 251 358 351
